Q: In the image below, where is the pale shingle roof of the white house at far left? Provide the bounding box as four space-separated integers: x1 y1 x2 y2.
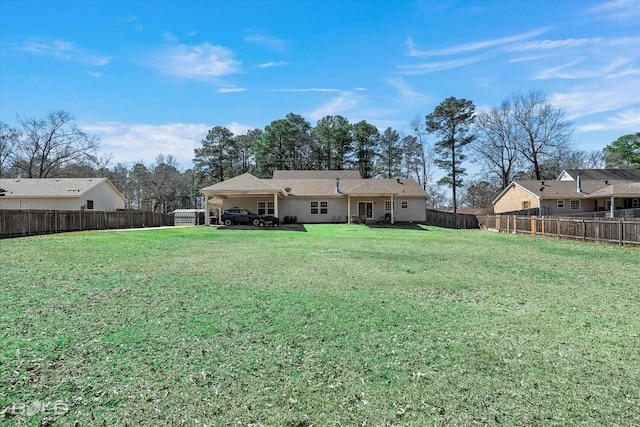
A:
0 178 117 198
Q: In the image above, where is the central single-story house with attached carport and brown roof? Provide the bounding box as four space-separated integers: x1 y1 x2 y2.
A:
200 170 427 223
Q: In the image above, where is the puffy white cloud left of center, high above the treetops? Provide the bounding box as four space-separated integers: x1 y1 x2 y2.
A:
155 43 240 81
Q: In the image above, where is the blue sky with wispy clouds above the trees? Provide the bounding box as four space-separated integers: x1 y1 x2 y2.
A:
0 0 640 168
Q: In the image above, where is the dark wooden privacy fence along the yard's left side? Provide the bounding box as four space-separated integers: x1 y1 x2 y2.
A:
0 210 172 238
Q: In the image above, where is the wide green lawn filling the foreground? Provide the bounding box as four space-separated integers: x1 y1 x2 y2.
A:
0 225 640 426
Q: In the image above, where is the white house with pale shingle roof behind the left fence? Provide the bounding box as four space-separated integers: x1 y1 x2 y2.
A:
0 178 125 211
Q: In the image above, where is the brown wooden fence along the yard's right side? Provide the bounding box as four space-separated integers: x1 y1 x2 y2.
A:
478 215 640 245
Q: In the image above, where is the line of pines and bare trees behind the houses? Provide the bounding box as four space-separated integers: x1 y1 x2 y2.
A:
0 90 640 212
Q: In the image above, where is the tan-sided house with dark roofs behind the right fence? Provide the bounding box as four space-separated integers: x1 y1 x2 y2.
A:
493 169 640 216
